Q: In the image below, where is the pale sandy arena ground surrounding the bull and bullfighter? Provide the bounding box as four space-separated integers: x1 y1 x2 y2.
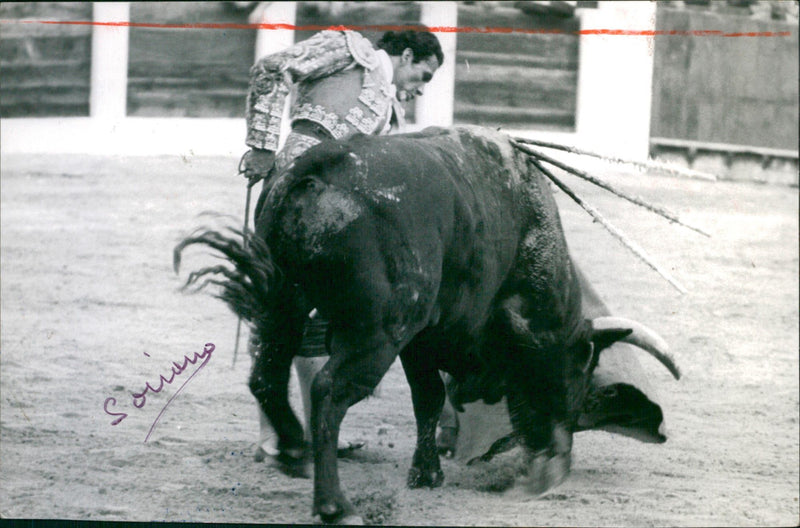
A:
0 151 800 526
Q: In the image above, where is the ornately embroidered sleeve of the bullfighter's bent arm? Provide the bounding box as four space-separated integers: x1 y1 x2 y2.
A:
245 31 354 151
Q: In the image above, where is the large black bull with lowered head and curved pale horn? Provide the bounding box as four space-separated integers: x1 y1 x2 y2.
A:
176 128 677 521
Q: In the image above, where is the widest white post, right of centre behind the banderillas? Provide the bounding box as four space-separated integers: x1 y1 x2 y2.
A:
576 1 656 159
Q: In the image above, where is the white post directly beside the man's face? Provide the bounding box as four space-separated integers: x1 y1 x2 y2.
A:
414 2 458 128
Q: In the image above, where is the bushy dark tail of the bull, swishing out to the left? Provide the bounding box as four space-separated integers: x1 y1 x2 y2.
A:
173 228 283 326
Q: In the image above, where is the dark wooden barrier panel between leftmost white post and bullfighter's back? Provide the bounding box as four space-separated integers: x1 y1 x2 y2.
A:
127 2 255 117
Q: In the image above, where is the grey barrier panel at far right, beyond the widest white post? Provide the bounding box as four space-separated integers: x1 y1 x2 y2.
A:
651 5 800 148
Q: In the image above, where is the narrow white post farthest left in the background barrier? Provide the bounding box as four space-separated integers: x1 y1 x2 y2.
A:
89 2 130 120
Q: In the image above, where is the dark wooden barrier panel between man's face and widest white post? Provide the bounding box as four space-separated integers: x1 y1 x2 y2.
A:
454 3 579 131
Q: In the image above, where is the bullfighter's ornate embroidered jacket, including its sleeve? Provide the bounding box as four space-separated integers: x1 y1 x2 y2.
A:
246 31 395 151
